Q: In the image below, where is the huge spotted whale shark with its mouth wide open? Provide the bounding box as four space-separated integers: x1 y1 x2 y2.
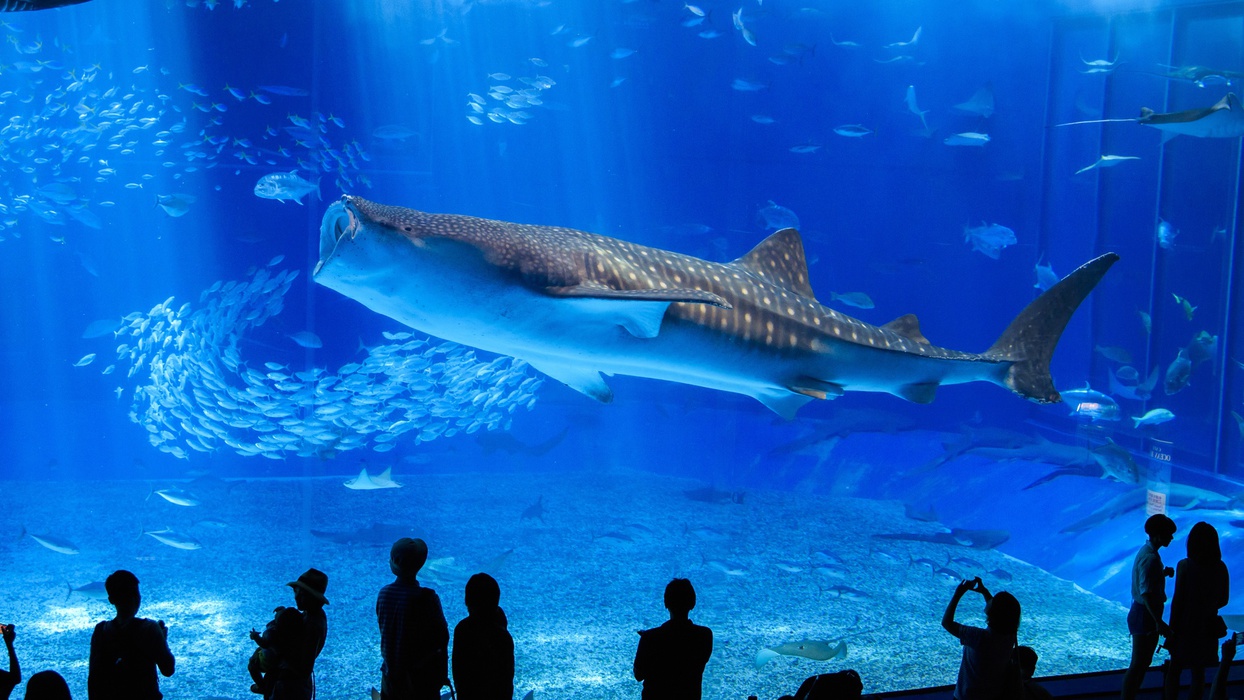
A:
312 195 1118 418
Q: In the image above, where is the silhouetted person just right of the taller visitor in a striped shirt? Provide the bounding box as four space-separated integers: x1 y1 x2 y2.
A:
453 573 514 700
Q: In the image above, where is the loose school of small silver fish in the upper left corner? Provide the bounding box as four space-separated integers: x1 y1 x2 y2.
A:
0 21 371 242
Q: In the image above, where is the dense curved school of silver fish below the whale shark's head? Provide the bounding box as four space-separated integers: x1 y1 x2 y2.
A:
104 267 544 459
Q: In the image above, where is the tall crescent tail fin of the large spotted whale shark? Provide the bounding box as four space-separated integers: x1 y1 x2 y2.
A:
984 252 1118 403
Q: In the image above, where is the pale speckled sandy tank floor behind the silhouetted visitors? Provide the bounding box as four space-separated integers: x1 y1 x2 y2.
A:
0 471 1128 700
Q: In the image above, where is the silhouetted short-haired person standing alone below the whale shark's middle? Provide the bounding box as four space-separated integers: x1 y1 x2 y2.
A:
634 578 713 700
